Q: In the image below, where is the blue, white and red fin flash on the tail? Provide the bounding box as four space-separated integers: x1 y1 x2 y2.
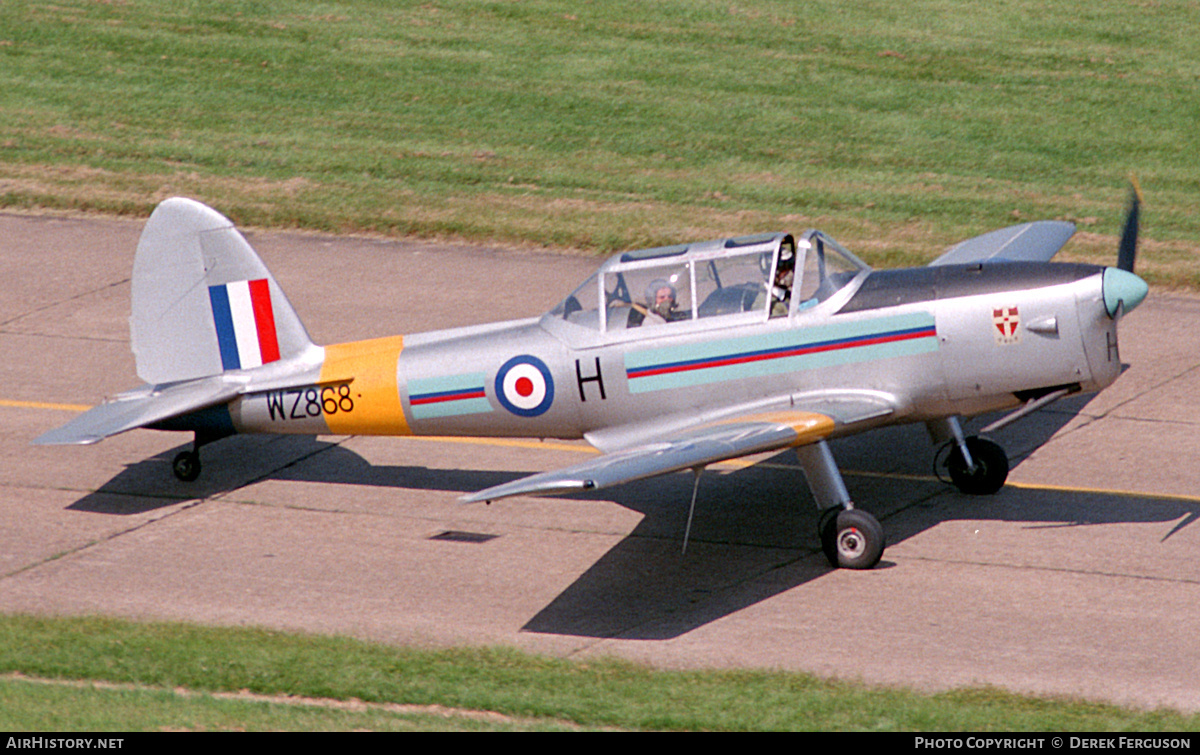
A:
209 278 280 370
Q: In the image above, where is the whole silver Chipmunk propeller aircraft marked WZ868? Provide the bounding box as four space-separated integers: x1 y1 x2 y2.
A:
36 187 1147 569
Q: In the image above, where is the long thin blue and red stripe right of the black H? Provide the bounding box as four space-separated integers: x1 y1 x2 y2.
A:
625 318 937 381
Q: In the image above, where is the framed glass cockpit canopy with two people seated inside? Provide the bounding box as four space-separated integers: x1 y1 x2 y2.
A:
544 230 870 334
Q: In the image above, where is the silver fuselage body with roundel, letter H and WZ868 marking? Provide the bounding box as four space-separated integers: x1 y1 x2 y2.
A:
229 263 1120 450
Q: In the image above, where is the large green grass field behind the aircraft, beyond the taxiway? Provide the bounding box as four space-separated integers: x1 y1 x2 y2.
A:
0 0 1200 286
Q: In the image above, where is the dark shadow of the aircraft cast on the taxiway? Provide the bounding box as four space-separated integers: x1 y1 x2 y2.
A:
70 391 1200 640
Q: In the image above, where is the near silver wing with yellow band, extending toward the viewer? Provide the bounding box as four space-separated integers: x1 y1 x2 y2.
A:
460 395 895 503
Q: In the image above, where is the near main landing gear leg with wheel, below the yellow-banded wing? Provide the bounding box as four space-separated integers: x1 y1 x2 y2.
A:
796 441 886 569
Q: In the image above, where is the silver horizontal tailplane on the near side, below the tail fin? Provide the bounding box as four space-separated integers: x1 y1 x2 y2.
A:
34 376 242 445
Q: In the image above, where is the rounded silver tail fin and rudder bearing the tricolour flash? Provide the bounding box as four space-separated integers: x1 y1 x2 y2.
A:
130 198 312 384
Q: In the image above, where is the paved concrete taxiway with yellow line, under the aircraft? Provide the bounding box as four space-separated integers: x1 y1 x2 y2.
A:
0 208 1200 712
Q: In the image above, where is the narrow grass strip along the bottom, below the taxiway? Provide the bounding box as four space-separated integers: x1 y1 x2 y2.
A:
0 616 1200 732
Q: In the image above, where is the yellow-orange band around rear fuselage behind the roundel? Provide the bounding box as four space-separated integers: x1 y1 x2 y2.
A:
320 336 412 436
